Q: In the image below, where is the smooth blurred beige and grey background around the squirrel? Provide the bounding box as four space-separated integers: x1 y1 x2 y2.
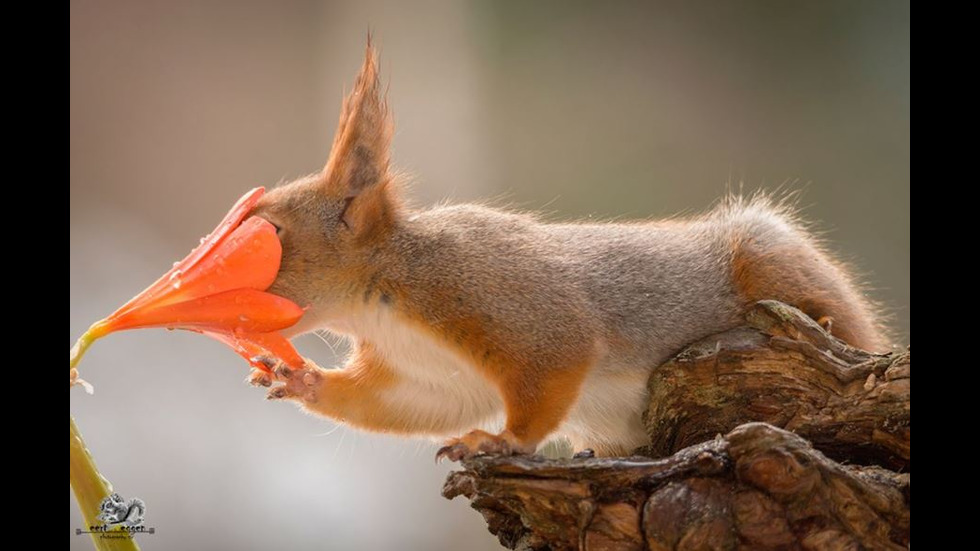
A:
69 0 911 550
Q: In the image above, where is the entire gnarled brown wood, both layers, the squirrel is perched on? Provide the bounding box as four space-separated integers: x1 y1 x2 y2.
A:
443 301 911 550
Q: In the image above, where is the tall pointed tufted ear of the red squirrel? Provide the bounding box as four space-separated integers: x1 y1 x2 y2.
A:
322 40 393 200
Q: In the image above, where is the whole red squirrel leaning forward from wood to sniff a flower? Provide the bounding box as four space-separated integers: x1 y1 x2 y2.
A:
252 44 888 460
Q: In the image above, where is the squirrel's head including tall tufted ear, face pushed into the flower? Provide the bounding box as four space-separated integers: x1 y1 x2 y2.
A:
253 39 400 332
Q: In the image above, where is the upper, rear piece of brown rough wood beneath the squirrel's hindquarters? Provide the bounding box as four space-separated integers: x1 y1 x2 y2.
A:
643 301 911 472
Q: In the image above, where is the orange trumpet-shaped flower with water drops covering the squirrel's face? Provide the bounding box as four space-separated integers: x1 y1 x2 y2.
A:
69 188 303 377
